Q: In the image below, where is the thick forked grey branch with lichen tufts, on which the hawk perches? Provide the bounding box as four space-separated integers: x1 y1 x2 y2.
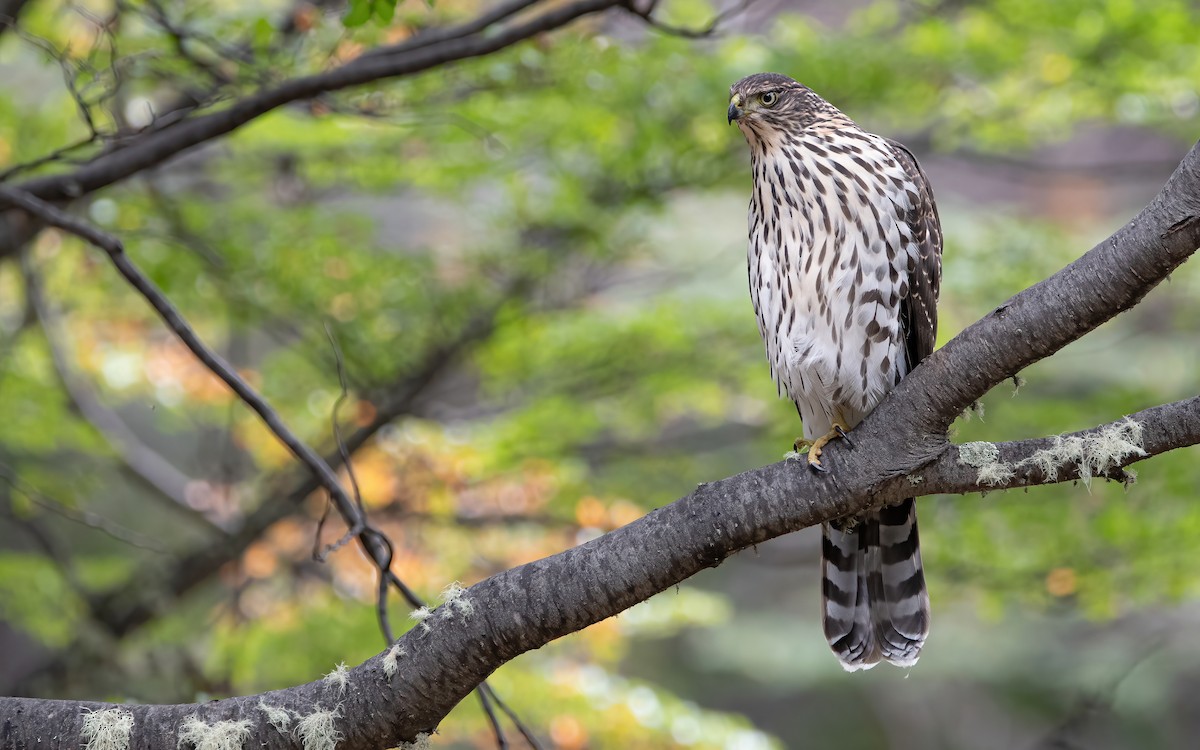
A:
0 136 1200 750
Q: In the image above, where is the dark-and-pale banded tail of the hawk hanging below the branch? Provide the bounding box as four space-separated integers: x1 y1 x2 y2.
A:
821 499 929 672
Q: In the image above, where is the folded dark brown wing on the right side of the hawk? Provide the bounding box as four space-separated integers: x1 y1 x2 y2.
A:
888 139 942 371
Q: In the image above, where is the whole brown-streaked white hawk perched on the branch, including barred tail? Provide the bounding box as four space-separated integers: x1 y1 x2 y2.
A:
728 73 942 671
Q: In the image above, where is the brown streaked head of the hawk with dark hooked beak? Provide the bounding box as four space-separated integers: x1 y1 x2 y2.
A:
728 73 848 142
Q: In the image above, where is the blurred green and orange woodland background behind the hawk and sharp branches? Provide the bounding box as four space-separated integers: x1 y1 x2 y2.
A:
0 0 1200 750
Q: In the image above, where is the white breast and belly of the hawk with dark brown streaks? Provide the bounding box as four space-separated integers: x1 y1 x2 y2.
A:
749 131 918 439
